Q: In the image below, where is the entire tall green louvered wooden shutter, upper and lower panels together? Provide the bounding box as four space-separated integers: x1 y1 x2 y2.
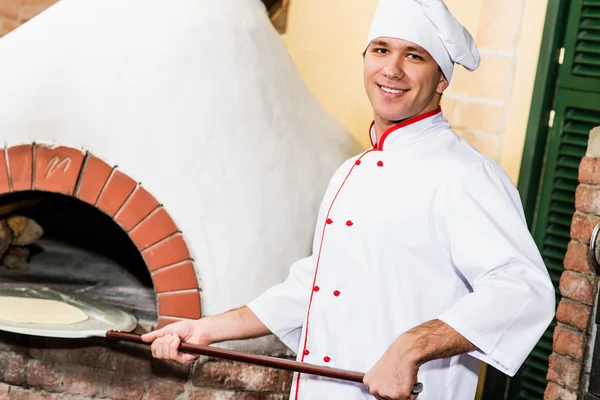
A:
508 0 600 400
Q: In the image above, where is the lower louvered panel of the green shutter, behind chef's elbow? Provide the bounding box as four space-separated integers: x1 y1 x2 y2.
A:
509 89 600 400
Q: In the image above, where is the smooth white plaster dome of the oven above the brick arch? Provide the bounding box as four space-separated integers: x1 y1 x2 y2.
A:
0 0 360 350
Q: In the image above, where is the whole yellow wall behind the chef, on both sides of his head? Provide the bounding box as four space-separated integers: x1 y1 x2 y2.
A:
282 0 547 183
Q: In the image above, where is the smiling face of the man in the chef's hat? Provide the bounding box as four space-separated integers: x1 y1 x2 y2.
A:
364 37 448 125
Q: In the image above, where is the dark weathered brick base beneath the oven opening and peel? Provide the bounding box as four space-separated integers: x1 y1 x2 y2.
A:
0 333 291 400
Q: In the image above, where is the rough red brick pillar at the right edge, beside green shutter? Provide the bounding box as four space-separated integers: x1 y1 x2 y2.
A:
544 127 600 400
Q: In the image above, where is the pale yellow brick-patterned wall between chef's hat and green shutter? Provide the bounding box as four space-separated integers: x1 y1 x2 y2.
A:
442 0 524 161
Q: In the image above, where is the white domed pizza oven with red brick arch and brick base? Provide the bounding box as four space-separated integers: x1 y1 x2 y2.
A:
0 0 360 400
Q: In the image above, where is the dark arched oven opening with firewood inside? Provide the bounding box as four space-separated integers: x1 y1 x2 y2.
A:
0 191 157 325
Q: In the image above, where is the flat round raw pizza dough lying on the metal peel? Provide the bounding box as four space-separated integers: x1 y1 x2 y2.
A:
0 296 89 325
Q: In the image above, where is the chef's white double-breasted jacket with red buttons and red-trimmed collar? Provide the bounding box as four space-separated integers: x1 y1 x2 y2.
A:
248 109 555 400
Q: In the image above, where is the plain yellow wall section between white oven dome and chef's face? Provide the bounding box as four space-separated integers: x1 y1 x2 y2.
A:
282 0 376 150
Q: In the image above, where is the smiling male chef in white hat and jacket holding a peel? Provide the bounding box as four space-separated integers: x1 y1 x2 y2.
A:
143 0 555 400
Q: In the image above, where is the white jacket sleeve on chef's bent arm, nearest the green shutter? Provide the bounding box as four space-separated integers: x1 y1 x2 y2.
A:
439 162 555 376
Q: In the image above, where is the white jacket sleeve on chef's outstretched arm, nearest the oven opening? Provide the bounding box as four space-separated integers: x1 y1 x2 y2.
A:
247 257 314 352
